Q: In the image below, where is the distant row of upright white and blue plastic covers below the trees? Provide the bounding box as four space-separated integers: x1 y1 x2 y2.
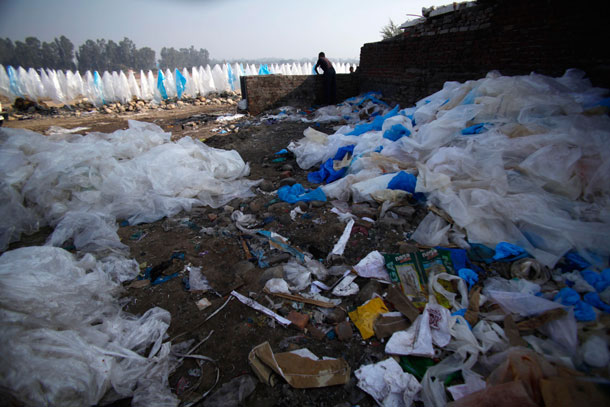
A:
0 63 351 106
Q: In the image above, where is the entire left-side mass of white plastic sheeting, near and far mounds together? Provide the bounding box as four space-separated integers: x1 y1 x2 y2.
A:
0 121 257 406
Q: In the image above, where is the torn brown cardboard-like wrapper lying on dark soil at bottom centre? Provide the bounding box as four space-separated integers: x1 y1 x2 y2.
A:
248 342 350 389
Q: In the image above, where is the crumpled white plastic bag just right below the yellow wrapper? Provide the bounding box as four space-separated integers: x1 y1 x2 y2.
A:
385 304 451 357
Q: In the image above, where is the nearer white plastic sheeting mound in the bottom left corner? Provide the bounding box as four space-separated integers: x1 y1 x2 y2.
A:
0 247 179 407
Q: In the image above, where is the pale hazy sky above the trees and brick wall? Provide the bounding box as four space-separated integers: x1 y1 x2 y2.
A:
0 0 460 60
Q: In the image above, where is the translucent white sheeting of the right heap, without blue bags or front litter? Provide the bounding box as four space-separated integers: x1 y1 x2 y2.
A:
289 70 610 266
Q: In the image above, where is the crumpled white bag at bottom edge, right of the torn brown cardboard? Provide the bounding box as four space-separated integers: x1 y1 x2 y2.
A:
354 358 421 407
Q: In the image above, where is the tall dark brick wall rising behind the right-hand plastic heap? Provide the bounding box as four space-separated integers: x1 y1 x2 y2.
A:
359 0 610 106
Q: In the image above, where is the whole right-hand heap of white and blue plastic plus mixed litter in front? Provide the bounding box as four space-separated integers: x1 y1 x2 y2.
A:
248 70 610 406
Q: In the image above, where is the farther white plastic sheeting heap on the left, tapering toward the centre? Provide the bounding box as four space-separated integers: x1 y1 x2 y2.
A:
0 121 257 251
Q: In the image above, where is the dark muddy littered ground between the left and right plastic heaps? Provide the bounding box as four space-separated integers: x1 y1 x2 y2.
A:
6 106 426 406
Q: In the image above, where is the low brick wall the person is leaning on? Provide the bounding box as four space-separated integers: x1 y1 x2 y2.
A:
241 74 359 115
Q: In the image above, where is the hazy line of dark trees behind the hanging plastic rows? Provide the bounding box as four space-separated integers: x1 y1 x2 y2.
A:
0 35 210 73
